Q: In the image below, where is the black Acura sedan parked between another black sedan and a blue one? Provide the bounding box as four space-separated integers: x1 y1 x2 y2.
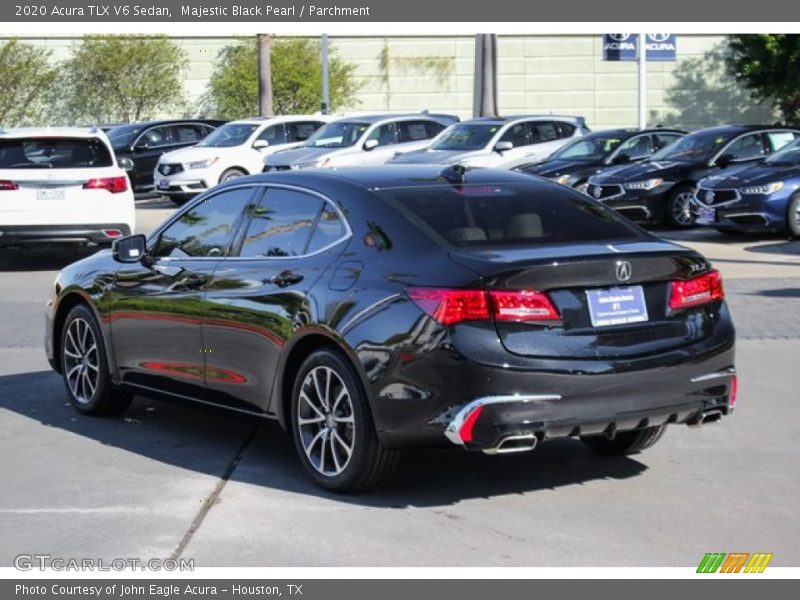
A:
586 125 800 227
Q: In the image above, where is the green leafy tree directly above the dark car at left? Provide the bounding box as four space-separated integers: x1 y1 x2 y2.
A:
63 35 187 123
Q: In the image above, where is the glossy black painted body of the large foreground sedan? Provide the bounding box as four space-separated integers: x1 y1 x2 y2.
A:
46 167 734 458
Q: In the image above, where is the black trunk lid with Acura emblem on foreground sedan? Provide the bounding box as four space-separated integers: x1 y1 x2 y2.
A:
451 241 709 358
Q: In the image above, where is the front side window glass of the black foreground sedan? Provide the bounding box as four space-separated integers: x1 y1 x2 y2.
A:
155 187 253 258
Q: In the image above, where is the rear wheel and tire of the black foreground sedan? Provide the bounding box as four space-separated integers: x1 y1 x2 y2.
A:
291 350 399 494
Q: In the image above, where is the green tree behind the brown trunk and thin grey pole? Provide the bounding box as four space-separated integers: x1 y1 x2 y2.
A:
206 38 358 119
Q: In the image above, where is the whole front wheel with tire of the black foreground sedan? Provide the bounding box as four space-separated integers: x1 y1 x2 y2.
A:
59 304 133 415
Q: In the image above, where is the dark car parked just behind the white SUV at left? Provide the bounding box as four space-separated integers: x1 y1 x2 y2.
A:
106 119 225 193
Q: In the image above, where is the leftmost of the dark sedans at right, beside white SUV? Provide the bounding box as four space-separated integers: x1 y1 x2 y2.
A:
514 127 686 191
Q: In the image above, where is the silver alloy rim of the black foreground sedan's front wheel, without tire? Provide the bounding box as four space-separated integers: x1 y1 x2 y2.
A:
63 318 100 404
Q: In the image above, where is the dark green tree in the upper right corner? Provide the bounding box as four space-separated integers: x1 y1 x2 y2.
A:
727 34 800 124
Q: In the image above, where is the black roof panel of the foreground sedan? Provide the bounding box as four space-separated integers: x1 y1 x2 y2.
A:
227 164 557 191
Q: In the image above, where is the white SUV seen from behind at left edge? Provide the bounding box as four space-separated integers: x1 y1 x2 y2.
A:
0 127 136 248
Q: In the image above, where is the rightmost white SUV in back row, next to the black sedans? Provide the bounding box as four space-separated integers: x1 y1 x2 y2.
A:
390 115 589 169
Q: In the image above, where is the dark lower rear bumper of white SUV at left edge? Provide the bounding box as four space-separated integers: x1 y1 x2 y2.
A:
0 223 131 247
